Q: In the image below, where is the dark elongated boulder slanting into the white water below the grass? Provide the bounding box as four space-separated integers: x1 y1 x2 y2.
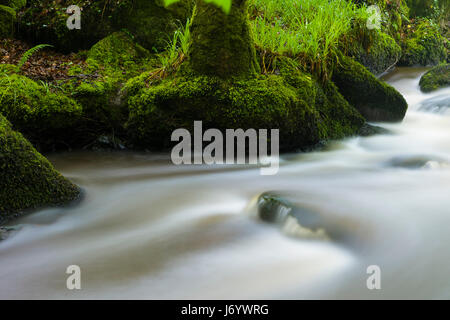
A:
332 55 408 122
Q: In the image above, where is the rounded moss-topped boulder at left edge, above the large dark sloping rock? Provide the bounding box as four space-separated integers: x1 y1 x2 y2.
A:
0 74 82 148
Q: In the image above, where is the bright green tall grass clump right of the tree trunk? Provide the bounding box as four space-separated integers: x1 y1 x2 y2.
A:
251 0 367 79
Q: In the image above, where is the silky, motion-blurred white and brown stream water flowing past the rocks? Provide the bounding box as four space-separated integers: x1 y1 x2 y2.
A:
0 68 450 299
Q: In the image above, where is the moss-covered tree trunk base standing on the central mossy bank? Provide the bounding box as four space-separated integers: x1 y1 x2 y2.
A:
190 0 259 78
